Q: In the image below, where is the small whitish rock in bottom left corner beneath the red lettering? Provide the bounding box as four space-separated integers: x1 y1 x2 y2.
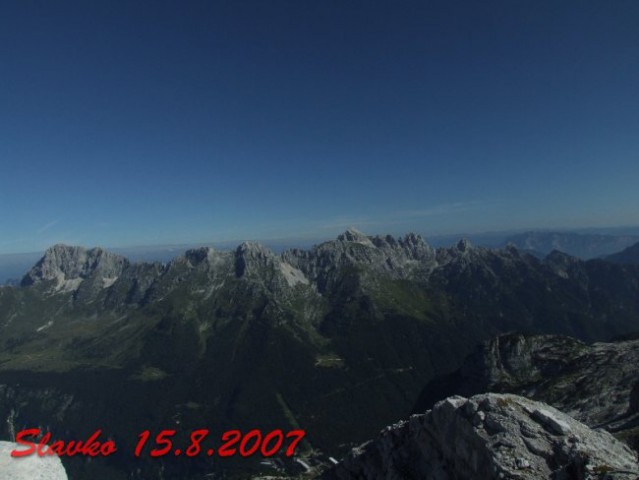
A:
0 442 68 480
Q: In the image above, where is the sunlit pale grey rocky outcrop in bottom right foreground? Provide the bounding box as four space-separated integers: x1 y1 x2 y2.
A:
325 394 639 480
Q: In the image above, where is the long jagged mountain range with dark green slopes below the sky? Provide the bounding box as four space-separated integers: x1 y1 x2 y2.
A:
0 230 639 480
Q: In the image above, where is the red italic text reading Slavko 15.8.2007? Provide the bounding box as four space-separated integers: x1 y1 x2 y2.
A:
11 428 305 457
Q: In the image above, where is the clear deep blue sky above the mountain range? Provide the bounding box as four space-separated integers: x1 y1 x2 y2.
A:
0 0 639 253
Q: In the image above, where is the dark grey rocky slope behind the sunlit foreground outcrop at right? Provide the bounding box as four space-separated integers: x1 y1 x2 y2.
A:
418 335 639 456
